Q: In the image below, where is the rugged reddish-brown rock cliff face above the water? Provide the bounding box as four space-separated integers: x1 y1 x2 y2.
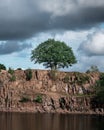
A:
0 70 102 112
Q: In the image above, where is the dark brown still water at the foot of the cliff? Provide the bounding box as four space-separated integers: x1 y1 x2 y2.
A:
0 112 104 130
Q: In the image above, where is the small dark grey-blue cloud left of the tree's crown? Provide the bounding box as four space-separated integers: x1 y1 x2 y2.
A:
0 41 32 55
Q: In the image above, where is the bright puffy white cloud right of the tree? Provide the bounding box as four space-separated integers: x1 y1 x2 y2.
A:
79 30 104 56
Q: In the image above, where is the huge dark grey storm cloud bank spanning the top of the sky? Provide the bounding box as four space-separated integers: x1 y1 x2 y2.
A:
0 0 104 40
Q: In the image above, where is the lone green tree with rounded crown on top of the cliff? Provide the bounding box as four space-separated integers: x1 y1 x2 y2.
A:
31 39 77 70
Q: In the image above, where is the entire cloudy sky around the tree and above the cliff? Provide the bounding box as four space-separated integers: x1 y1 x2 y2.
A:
0 0 104 71
